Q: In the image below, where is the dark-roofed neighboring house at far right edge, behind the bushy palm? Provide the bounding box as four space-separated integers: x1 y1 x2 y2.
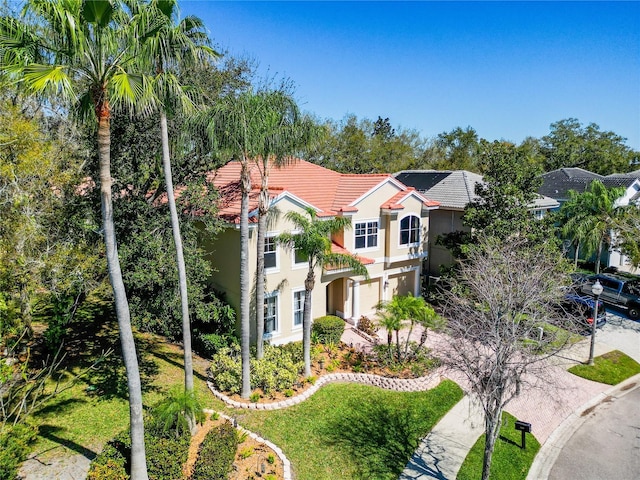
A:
538 167 640 271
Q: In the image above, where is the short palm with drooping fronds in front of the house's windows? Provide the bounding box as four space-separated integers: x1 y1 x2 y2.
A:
277 208 369 377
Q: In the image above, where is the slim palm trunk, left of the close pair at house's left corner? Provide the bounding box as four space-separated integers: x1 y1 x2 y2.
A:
240 158 251 398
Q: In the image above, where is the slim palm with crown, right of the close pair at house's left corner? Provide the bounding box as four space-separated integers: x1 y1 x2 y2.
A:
250 90 322 359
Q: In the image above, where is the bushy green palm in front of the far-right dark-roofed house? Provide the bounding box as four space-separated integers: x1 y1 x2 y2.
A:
560 180 626 273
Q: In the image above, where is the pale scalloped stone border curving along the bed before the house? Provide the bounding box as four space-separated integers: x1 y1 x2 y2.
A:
207 373 442 410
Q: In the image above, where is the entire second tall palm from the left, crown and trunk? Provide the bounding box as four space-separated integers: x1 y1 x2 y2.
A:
135 0 217 410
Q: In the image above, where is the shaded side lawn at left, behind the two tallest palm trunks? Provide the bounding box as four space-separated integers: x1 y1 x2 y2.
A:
32 328 223 459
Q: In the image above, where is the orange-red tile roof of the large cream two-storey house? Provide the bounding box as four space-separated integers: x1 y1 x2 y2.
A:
207 160 438 223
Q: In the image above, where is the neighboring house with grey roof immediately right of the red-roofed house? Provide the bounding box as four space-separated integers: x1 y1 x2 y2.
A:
394 170 559 276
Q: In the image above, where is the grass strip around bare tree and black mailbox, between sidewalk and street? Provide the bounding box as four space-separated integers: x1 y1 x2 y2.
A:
457 412 540 480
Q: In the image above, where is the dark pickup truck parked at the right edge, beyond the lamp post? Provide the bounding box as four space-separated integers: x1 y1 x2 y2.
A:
579 274 640 320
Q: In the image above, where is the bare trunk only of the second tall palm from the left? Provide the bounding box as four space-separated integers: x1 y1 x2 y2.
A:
160 110 196 434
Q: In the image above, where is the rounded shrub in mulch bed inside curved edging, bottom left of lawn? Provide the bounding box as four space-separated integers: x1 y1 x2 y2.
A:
192 422 238 480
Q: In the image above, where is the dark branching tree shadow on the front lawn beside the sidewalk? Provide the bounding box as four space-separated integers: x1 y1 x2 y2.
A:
322 401 423 480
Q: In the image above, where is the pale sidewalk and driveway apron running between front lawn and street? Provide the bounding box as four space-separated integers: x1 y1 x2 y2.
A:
400 316 640 480
